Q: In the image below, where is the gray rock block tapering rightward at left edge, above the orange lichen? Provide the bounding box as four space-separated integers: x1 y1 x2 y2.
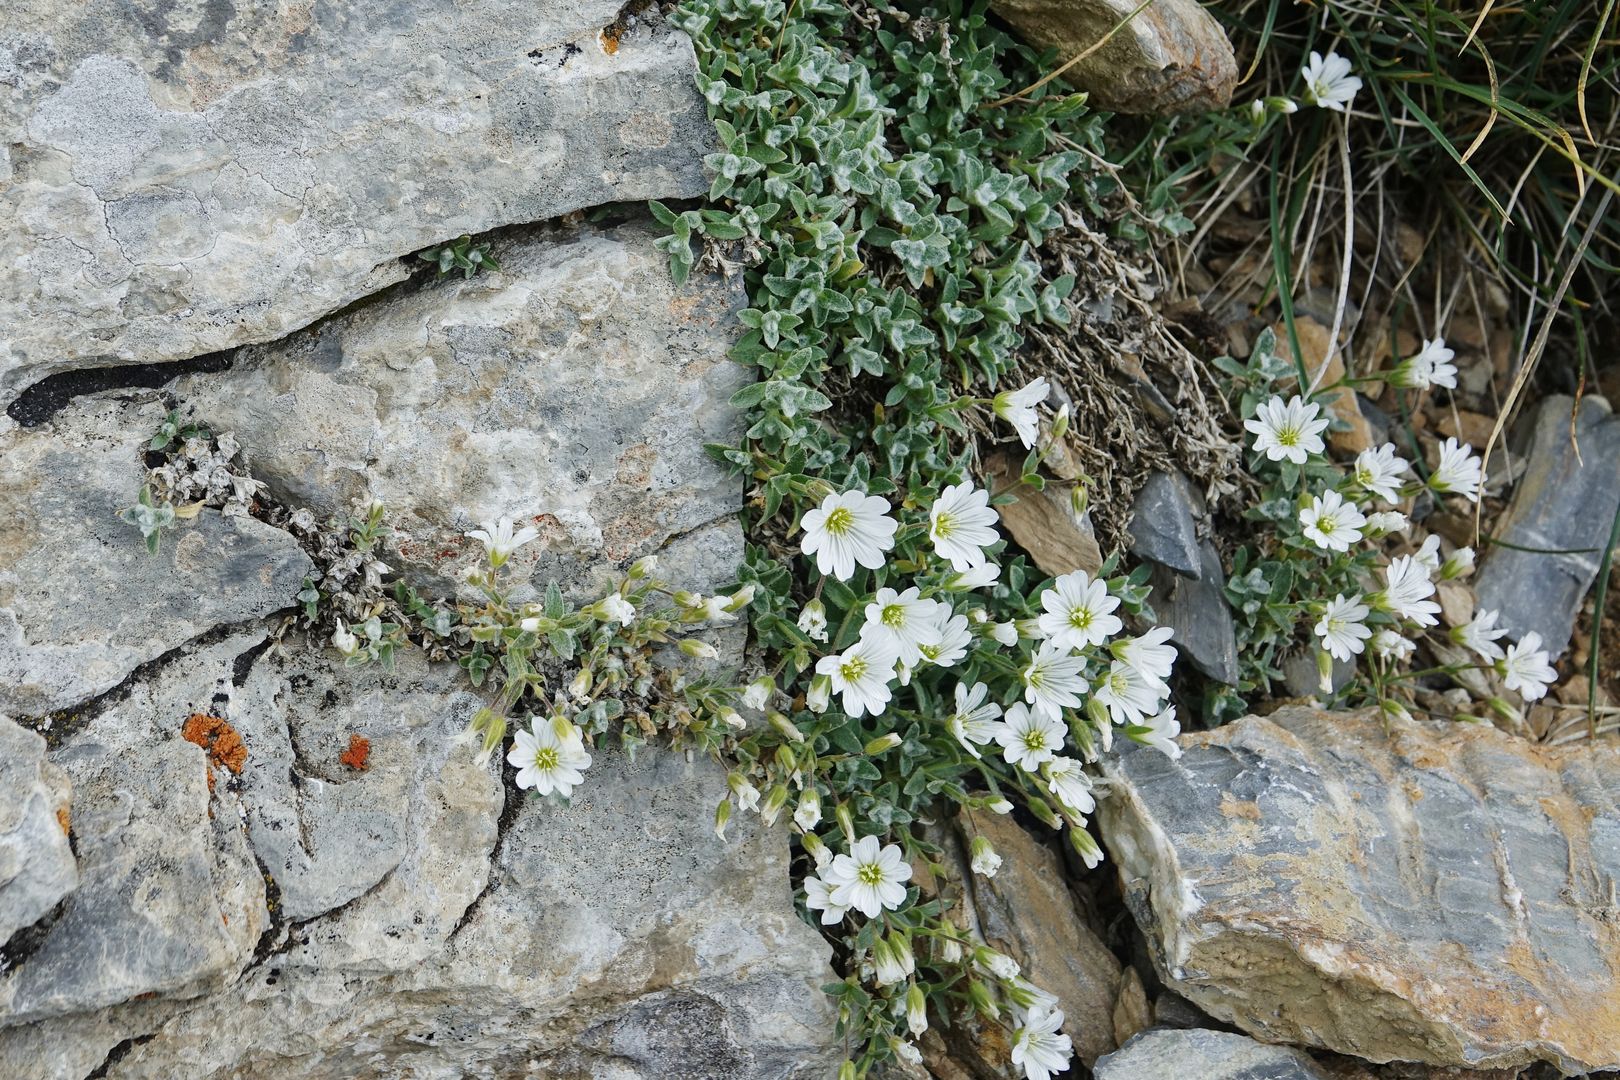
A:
0 395 311 716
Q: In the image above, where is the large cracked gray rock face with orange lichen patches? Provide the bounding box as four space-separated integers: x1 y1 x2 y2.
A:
0 0 841 1080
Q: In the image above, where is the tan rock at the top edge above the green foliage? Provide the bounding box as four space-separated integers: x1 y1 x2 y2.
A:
991 0 1238 115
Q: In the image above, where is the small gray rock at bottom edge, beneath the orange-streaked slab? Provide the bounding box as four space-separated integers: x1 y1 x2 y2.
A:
1092 1028 1328 1080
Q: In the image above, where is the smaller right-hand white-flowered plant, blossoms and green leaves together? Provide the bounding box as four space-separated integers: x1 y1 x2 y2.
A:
1213 332 1555 719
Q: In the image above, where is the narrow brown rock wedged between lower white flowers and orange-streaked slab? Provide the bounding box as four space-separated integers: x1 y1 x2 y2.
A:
962 814 1119 1065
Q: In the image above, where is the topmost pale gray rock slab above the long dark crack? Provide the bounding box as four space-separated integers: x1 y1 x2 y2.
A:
0 0 714 403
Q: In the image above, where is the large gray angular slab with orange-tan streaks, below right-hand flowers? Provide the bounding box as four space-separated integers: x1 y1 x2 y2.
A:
1100 708 1620 1075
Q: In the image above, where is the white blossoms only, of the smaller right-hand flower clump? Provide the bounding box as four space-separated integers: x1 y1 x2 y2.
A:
1244 393 1555 701
